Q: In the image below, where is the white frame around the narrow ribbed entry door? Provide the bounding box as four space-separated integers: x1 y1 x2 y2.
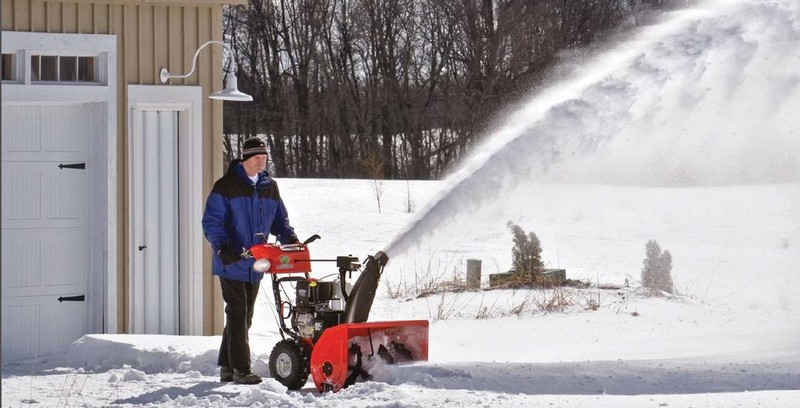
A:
126 85 204 335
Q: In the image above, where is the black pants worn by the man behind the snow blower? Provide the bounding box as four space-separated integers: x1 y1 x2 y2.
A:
217 277 259 371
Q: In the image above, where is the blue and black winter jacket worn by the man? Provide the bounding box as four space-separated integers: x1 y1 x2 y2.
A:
203 160 297 282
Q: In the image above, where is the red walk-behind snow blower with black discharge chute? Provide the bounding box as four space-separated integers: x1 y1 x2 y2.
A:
247 235 428 392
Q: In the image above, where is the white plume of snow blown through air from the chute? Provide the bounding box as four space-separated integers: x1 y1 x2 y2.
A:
384 0 800 257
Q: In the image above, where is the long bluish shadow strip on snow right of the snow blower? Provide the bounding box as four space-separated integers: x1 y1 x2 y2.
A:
384 360 800 395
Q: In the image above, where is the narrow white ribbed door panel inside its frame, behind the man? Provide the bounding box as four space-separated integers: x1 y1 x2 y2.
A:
129 109 180 334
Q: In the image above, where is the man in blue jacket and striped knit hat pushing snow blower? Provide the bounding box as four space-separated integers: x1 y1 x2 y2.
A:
203 137 298 384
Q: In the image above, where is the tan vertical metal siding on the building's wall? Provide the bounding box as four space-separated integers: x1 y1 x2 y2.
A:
2 0 231 334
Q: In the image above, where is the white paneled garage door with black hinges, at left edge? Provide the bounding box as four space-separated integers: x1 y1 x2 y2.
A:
2 102 93 361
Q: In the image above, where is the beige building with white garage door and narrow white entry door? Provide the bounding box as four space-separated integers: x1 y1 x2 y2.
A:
2 0 246 362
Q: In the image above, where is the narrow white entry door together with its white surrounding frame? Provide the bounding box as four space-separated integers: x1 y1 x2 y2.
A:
126 85 204 335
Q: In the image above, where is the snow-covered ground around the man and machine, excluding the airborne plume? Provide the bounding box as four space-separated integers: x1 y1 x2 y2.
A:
2 180 800 407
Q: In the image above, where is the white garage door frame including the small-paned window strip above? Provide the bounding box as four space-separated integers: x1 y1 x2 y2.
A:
2 31 118 333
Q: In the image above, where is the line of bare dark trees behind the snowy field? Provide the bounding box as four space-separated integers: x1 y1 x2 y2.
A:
223 0 670 179
